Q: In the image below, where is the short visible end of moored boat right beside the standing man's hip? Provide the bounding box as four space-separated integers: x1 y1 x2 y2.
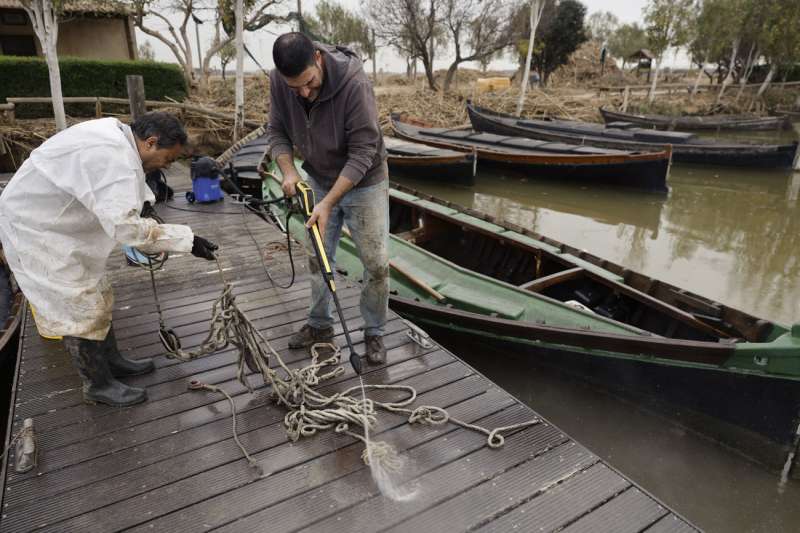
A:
384 137 477 185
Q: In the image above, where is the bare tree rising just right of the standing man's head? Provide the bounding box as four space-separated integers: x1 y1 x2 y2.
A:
369 0 444 91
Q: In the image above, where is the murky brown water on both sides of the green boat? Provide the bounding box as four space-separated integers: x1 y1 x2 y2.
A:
396 130 800 532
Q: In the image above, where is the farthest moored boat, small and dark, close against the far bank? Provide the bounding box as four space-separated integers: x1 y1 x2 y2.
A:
600 107 791 131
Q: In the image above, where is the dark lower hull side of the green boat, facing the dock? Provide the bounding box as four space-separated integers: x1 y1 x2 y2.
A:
404 305 800 476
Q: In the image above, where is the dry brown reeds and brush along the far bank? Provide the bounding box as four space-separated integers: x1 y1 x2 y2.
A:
0 46 800 172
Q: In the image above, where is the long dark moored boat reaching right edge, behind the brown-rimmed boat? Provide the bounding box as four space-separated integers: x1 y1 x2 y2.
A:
467 103 798 168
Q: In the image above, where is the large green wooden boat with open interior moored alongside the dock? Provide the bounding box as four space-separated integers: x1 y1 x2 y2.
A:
264 158 800 465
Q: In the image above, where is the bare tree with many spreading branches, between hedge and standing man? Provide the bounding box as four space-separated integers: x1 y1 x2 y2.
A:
131 0 297 92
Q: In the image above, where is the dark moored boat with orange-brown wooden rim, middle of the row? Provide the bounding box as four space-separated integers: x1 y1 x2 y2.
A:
392 114 670 193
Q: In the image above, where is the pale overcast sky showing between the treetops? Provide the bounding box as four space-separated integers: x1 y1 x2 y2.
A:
136 0 664 72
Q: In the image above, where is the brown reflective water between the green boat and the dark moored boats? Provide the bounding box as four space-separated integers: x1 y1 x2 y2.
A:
399 158 800 323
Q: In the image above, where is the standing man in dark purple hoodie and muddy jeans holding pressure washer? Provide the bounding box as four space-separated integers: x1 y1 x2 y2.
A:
268 33 389 364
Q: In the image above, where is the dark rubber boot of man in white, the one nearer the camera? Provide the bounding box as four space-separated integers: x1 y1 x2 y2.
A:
64 337 147 407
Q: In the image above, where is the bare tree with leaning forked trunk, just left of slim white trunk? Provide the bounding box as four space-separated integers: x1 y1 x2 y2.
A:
444 0 516 92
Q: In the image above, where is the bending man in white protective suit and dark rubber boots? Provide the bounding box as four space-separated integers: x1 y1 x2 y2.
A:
0 113 217 406
